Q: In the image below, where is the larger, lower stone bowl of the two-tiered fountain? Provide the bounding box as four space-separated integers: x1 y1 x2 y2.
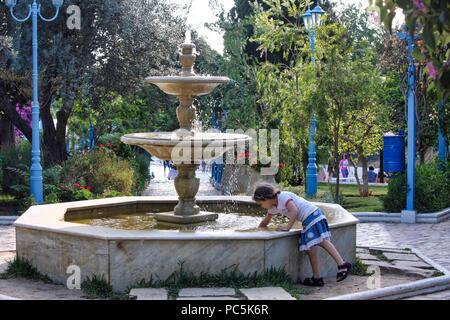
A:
120 131 251 164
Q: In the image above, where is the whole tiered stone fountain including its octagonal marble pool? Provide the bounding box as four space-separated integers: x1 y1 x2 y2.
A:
15 31 357 291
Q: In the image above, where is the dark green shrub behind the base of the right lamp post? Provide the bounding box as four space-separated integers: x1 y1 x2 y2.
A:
381 162 450 212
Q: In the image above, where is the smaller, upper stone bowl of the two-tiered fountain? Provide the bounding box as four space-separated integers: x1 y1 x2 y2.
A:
145 76 230 97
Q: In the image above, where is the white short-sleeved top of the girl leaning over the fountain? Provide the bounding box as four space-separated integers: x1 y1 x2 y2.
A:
267 191 319 222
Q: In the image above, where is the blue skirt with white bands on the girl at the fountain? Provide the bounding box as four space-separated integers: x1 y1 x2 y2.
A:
298 209 331 251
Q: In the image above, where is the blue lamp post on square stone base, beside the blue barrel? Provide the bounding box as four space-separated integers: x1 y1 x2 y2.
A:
397 25 417 223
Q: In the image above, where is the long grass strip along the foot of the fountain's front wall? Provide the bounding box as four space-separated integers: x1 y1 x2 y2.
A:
128 263 310 299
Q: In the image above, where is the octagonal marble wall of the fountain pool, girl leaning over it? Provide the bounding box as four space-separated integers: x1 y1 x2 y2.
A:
15 196 358 291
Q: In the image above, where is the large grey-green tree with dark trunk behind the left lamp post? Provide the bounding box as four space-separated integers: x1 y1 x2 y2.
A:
0 0 184 166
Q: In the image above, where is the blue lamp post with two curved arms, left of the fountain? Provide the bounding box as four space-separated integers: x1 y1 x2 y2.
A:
5 0 63 204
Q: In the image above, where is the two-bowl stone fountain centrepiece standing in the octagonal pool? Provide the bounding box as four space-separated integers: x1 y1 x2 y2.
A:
121 31 251 225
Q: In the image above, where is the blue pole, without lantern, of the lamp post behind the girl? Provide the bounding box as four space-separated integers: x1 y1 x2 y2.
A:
306 29 317 197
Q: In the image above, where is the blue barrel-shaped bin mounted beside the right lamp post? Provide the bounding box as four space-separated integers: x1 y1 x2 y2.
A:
383 134 405 172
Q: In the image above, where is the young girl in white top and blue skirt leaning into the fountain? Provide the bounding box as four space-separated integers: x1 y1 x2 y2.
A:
253 183 352 287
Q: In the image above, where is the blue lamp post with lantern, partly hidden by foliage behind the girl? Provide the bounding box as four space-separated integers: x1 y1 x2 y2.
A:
302 3 325 197
